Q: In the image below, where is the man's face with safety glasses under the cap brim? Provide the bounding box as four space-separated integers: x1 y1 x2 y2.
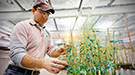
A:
34 7 50 27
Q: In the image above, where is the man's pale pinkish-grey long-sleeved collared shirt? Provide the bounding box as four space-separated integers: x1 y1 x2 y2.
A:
10 19 56 67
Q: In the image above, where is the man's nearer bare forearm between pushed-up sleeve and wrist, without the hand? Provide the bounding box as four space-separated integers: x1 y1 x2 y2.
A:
21 54 44 69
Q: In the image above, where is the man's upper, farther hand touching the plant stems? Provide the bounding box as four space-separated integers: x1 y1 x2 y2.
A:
51 45 71 57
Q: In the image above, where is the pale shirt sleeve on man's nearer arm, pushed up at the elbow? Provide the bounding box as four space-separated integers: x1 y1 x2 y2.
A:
9 23 27 66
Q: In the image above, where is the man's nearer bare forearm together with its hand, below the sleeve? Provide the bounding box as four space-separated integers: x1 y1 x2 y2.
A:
21 54 67 74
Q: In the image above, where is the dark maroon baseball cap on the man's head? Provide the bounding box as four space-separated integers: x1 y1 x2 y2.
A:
33 0 55 14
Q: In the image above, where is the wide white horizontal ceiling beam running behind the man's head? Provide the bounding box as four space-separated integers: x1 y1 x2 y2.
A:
0 5 135 20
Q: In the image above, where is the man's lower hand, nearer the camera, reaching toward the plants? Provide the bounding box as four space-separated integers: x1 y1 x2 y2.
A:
42 58 67 74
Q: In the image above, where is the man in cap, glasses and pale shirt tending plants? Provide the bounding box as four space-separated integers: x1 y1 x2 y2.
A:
4 0 67 75
